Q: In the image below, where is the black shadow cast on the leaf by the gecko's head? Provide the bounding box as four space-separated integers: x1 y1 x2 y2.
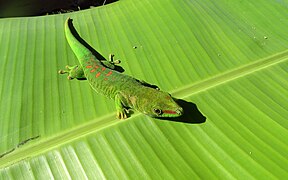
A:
156 99 206 124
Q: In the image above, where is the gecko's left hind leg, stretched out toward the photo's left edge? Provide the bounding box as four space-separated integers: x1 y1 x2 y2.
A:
58 65 86 80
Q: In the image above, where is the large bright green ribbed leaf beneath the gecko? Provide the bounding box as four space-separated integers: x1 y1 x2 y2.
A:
0 0 288 179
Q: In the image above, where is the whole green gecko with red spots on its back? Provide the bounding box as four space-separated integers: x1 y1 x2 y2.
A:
59 18 183 119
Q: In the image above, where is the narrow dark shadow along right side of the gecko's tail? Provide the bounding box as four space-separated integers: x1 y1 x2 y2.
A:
68 19 125 74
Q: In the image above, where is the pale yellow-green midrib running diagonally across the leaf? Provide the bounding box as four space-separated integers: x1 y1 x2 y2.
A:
0 50 288 168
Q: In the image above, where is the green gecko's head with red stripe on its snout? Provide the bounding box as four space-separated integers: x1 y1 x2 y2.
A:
143 90 183 118
